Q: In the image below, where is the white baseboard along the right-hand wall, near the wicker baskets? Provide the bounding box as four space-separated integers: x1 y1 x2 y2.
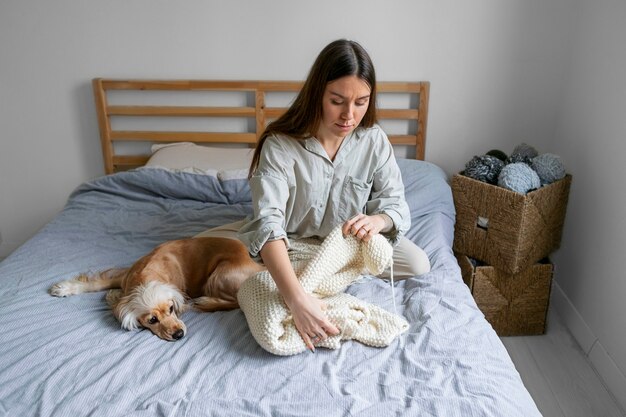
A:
550 281 626 410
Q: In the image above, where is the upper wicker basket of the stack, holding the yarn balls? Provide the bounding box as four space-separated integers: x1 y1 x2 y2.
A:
452 174 572 274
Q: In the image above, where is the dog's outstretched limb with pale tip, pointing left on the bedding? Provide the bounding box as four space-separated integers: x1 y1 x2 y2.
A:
48 268 128 297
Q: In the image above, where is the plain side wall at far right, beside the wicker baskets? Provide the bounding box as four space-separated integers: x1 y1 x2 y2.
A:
550 0 626 409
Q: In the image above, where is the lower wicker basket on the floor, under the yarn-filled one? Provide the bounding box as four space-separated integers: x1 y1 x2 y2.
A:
456 253 553 336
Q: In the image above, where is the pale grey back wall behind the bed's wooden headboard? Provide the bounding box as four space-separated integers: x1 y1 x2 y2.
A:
0 0 567 257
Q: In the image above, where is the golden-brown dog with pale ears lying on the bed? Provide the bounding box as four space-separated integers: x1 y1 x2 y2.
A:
50 237 264 340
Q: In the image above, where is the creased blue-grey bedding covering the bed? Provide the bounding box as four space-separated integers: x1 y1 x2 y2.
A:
0 160 540 417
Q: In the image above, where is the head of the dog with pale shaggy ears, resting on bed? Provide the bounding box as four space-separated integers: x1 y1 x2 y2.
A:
112 281 187 341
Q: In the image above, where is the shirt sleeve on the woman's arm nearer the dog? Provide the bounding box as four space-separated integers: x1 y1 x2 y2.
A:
239 137 290 256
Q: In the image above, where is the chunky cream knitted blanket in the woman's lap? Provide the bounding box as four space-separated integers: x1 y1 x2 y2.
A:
237 227 409 355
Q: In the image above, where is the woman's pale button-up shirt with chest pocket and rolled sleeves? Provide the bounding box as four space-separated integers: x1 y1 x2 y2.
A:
239 126 411 256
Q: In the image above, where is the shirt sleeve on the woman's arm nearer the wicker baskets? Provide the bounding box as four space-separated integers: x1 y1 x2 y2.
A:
366 132 411 245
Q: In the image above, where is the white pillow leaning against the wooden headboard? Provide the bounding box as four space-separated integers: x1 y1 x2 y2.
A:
145 142 254 179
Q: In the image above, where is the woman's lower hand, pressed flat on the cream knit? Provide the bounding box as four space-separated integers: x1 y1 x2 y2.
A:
285 292 340 351
